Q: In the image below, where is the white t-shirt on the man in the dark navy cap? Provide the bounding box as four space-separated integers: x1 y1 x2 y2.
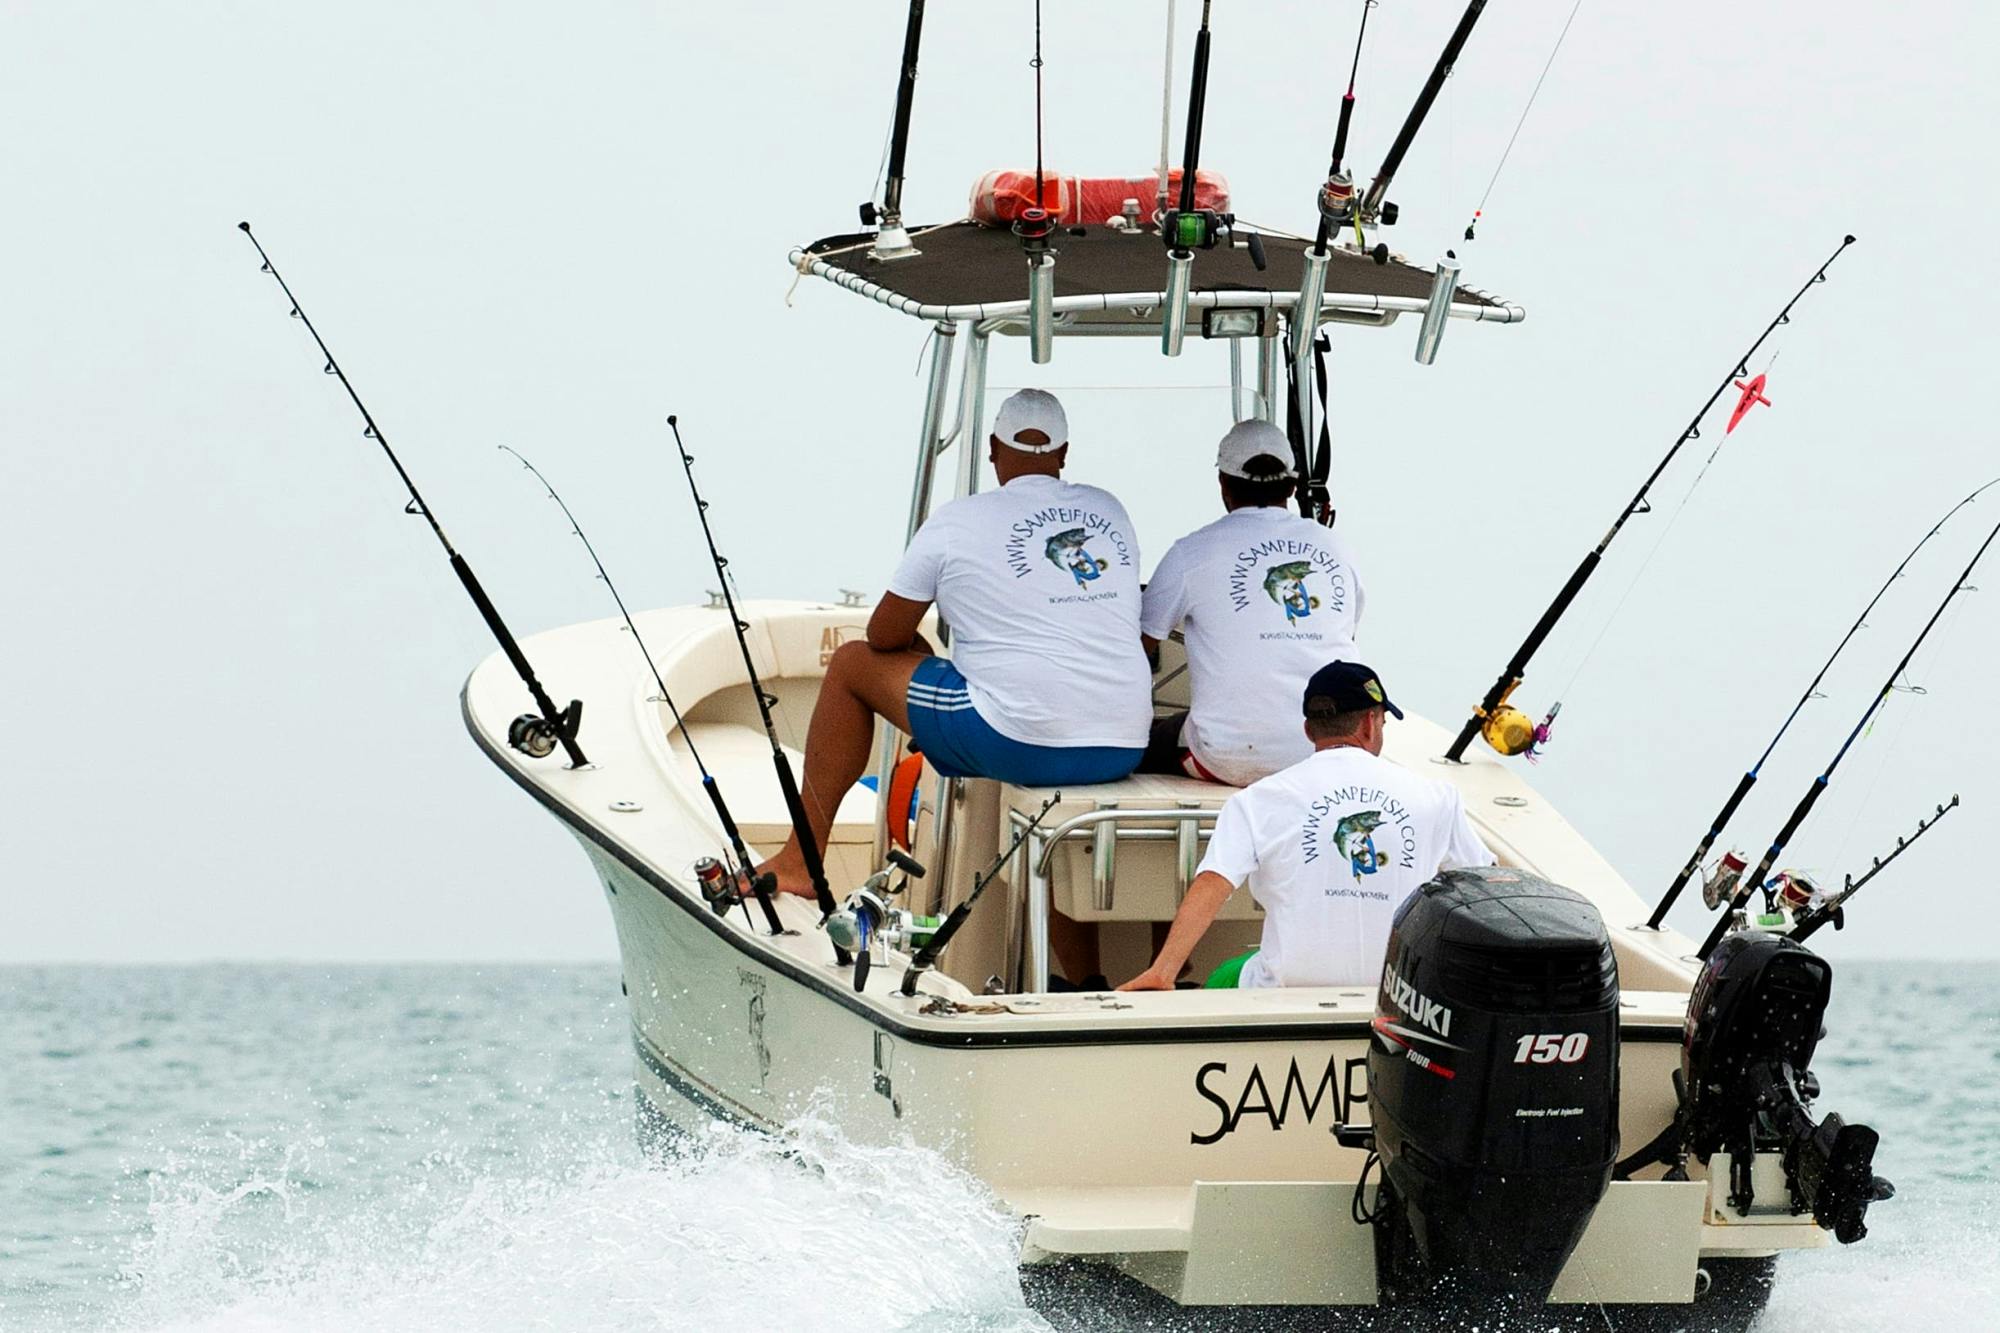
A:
1202 745 1494 987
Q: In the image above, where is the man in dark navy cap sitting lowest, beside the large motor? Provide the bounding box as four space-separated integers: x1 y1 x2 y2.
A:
1120 660 1494 991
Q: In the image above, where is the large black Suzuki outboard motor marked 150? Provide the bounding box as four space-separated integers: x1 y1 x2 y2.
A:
1368 867 1618 1303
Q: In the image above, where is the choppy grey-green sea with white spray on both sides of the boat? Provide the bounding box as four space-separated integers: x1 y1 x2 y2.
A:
0 963 2000 1333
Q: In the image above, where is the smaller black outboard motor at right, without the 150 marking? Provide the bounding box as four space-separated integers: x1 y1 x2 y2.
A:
1680 931 1896 1243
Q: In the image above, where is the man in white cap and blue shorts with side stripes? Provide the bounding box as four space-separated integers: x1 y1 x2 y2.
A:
760 388 1152 981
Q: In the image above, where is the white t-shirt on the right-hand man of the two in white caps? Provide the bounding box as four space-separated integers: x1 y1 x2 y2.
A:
1140 506 1362 787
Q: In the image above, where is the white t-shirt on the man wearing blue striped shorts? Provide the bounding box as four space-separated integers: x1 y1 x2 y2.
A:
888 476 1152 749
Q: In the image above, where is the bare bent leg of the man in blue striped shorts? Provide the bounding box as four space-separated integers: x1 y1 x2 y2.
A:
758 642 926 897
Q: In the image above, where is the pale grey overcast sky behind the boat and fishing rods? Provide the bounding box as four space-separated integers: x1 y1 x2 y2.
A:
0 0 2000 961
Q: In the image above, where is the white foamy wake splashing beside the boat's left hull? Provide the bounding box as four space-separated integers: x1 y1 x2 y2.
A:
114 1113 1048 1333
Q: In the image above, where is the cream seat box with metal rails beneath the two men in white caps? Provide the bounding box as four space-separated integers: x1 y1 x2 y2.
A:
1000 773 1262 921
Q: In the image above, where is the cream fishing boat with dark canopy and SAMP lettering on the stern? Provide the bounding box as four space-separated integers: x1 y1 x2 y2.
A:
244 0 1904 1311
